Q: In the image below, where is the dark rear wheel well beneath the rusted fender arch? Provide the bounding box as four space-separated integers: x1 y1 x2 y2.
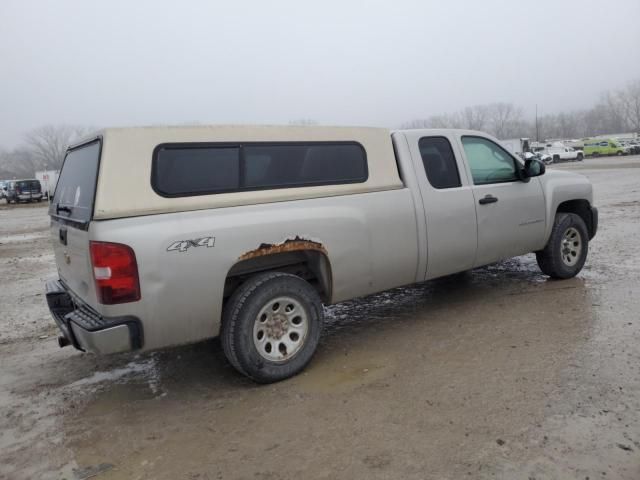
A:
224 250 332 304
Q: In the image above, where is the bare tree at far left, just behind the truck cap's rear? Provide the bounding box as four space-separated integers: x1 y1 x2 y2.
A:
25 125 87 169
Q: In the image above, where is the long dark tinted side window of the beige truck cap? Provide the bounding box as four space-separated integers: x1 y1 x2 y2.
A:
151 142 368 197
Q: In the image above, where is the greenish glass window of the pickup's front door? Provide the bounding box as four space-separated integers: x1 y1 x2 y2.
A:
462 136 518 185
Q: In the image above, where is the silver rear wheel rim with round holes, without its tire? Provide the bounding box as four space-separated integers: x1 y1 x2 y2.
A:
253 297 309 362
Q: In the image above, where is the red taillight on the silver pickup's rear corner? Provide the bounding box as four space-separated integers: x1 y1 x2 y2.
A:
90 242 140 305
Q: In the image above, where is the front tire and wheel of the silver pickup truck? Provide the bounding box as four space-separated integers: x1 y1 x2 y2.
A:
536 213 589 279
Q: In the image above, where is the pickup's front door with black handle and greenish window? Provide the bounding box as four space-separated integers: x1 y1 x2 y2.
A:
460 135 546 267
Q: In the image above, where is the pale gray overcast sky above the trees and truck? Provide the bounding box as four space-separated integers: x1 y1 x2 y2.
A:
0 0 640 147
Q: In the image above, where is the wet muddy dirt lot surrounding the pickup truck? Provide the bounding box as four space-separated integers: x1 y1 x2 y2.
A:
0 157 640 480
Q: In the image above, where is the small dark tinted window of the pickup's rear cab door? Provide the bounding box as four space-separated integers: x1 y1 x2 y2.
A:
418 137 462 188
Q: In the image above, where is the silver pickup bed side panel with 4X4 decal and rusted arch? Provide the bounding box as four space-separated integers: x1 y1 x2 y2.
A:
90 188 418 349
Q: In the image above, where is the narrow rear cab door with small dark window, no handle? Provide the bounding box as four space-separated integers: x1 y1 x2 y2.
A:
405 131 477 279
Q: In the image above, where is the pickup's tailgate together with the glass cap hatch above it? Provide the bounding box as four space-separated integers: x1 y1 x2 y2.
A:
49 140 101 307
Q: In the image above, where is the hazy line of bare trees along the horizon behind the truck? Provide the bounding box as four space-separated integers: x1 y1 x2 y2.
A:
0 79 640 180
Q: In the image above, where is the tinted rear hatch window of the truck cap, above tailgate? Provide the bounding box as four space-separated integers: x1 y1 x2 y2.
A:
49 140 100 223
